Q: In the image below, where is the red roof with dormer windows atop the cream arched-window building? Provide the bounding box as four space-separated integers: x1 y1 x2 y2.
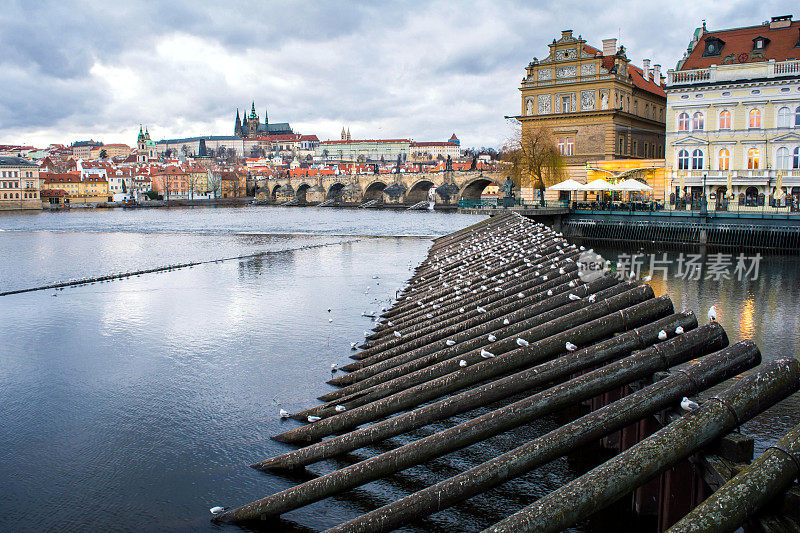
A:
678 20 800 70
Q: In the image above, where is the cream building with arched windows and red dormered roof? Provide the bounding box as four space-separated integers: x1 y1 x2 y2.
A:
666 15 800 209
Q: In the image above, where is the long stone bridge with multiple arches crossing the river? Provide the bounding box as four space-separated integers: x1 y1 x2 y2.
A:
257 169 507 206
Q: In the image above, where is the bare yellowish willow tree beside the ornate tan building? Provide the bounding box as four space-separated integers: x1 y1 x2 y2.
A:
504 124 565 190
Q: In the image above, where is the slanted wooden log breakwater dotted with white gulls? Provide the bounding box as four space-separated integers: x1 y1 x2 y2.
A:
213 214 800 533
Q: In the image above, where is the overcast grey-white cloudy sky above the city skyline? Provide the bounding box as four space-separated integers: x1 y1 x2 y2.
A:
0 0 800 150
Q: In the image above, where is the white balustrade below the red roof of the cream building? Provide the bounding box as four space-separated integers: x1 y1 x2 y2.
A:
667 59 800 87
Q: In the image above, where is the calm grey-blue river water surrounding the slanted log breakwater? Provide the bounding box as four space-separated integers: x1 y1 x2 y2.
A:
0 207 800 531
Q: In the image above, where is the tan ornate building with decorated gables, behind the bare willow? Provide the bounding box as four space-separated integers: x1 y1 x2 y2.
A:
515 30 666 171
